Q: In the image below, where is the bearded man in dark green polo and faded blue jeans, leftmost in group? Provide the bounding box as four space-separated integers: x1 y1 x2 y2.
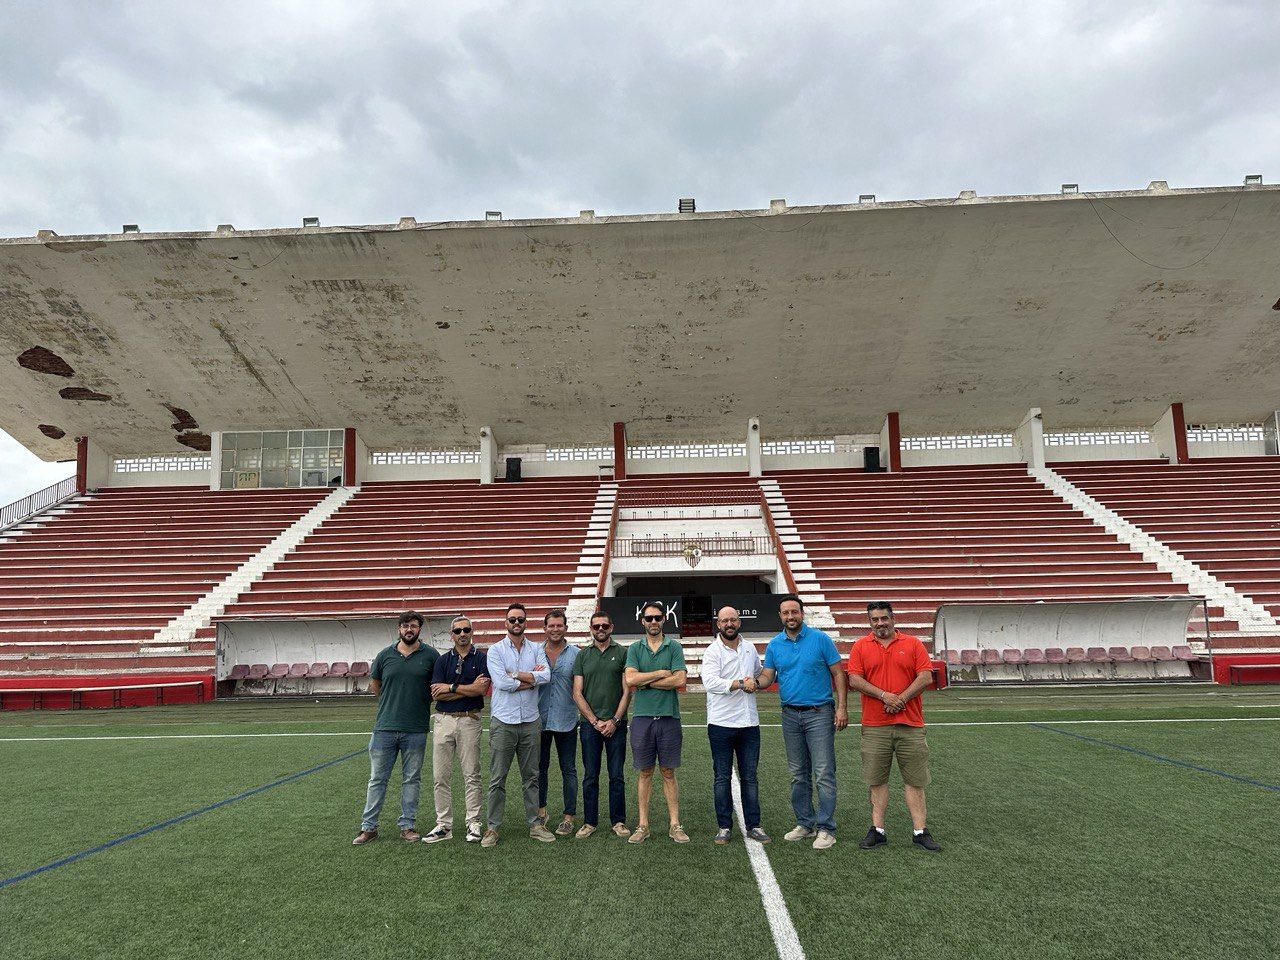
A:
351 611 439 846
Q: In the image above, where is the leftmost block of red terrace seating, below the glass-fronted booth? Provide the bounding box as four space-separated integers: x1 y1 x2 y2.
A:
0 486 329 682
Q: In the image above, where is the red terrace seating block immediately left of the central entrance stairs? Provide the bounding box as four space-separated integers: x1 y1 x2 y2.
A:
213 477 612 643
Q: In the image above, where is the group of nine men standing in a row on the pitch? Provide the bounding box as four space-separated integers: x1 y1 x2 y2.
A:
353 595 941 851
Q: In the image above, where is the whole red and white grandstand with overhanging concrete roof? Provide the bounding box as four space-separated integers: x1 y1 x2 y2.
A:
0 182 1280 707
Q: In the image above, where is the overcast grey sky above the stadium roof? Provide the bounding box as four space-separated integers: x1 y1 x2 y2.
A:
0 0 1280 502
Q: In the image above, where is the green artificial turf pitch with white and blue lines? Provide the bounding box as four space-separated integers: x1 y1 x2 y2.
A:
0 687 1280 960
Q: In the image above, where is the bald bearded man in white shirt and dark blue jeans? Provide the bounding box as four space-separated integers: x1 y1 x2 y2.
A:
703 607 769 844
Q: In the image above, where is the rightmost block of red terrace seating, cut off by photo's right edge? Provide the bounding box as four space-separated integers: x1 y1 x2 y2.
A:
1050 457 1280 650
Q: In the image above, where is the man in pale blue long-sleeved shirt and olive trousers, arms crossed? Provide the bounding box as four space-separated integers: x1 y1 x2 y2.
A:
480 603 556 847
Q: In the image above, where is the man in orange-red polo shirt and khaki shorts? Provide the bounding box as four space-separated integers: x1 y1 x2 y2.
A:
845 600 942 852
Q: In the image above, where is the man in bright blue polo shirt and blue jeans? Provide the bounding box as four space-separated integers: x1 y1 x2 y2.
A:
758 594 849 850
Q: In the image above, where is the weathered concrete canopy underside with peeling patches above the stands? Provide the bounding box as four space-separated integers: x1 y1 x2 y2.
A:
0 187 1280 460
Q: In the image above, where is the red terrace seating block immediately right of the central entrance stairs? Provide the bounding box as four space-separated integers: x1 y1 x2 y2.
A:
762 465 1236 644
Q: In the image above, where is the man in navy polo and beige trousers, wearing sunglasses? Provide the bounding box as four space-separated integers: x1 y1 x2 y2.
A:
422 617 489 844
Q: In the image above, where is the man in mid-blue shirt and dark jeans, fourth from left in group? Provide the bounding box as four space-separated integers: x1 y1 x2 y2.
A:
538 609 577 837
